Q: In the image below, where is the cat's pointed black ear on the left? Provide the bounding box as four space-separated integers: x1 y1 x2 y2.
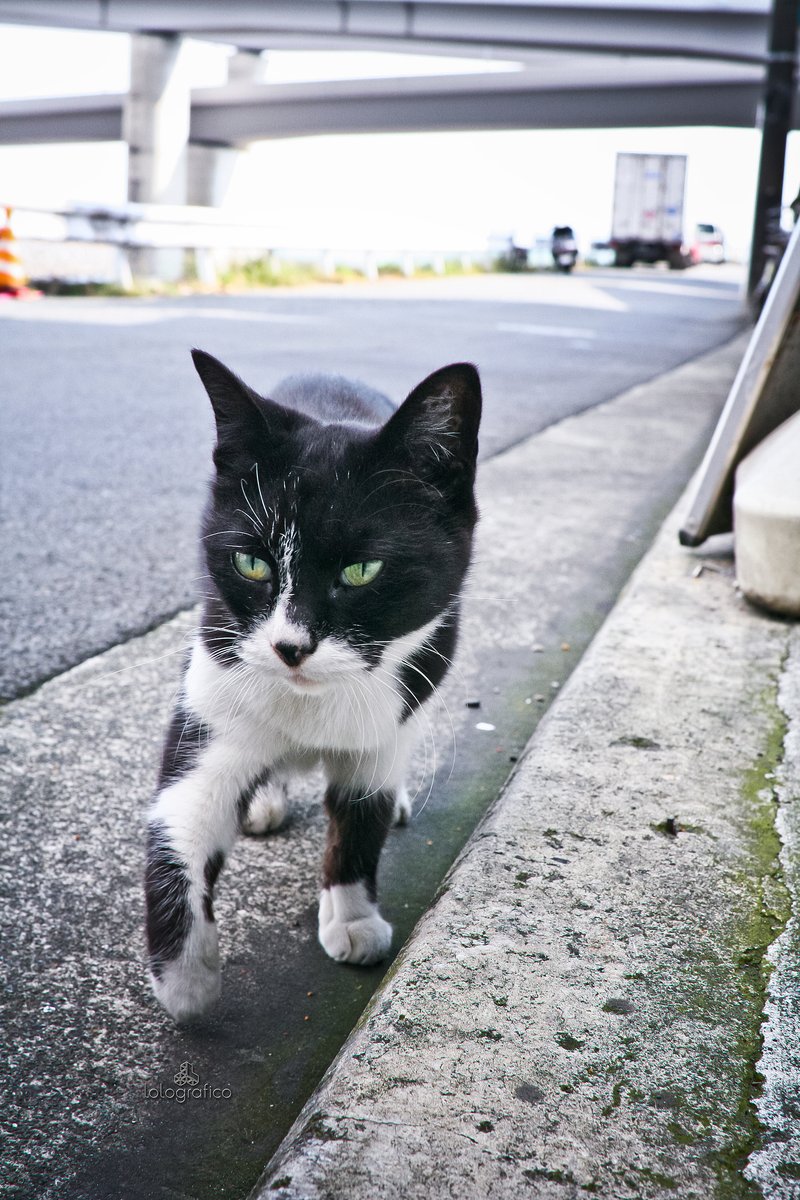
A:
192 349 296 467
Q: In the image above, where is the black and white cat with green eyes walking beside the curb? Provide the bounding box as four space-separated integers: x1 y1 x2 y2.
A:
146 350 481 1020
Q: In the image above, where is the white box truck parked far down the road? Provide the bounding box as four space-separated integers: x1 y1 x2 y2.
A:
610 154 691 270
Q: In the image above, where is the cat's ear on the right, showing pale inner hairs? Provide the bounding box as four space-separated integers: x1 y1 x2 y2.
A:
380 362 481 479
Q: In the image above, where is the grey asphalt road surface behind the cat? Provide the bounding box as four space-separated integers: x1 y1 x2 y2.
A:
0 268 742 700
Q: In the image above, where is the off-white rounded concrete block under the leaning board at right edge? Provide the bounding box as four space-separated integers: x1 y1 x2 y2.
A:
734 413 800 617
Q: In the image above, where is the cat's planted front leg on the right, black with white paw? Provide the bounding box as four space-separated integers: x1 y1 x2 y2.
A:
319 784 395 966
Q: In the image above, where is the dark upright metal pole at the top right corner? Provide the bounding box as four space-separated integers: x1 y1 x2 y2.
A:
747 0 800 300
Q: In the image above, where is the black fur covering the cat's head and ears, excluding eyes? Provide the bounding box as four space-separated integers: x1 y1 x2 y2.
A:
193 350 481 676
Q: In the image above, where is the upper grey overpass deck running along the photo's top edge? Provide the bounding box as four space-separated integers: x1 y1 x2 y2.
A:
0 0 769 62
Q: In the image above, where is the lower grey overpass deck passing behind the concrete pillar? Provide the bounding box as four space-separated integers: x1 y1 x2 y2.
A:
0 54 763 146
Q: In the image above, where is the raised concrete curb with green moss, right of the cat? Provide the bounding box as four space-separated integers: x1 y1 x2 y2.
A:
253 477 800 1200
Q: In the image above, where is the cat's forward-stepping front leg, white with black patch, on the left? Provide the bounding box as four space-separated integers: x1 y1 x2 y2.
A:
145 746 250 1021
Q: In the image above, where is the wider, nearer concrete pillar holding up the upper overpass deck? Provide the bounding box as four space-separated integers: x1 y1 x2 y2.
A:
122 34 191 281
